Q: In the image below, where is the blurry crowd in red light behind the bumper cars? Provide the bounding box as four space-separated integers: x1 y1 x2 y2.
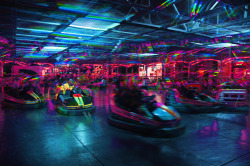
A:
0 71 250 101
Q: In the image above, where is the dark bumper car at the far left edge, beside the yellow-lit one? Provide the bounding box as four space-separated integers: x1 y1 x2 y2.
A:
2 87 47 109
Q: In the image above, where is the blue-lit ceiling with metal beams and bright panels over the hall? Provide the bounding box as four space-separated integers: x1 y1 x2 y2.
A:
0 0 250 64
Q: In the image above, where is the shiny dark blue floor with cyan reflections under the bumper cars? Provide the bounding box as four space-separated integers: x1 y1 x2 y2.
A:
0 89 250 166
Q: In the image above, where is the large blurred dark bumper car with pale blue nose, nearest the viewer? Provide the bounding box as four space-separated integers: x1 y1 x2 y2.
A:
108 87 185 137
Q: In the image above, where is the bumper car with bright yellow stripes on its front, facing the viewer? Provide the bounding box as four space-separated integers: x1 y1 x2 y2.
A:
56 88 95 115
